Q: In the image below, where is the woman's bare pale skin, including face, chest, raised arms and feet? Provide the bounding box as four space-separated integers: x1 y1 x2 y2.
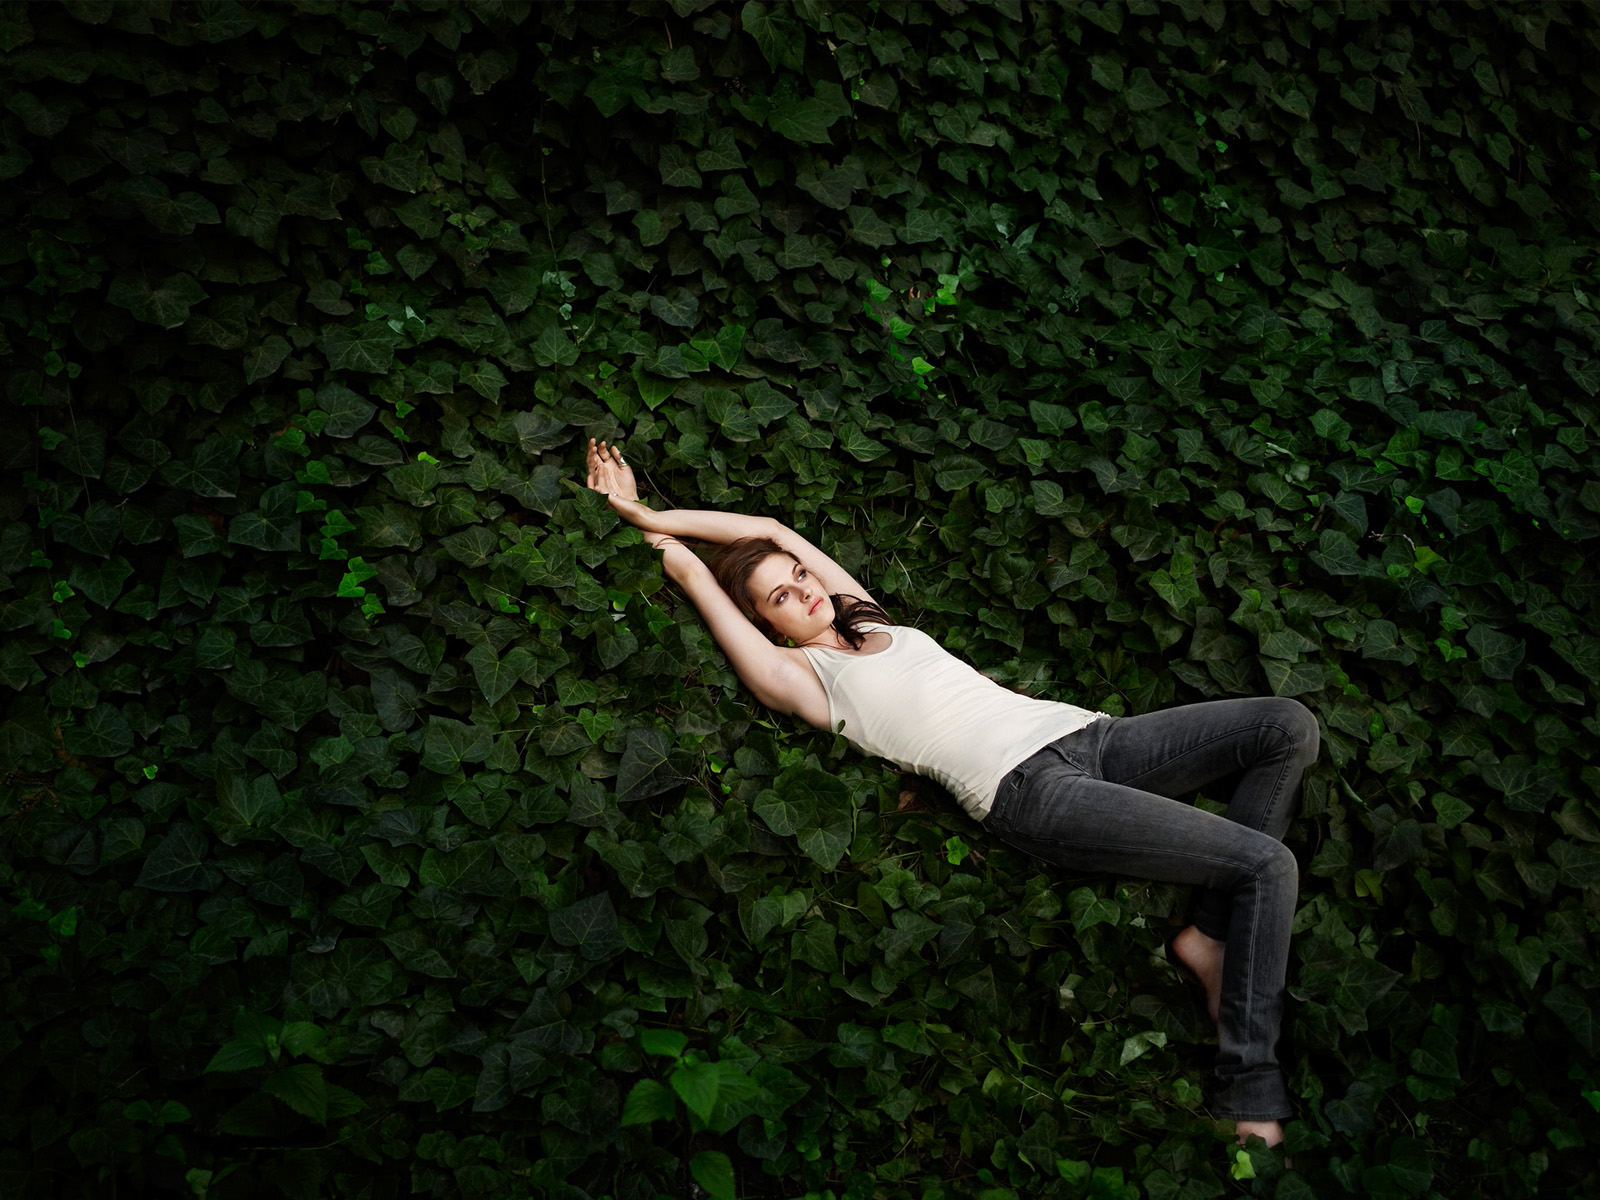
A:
586 438 1283 1146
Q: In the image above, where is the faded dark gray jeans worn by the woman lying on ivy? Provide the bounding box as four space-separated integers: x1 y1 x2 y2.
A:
984 698 1318 1120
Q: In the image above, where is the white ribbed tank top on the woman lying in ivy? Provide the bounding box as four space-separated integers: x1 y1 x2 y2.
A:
802 626 1107 821
